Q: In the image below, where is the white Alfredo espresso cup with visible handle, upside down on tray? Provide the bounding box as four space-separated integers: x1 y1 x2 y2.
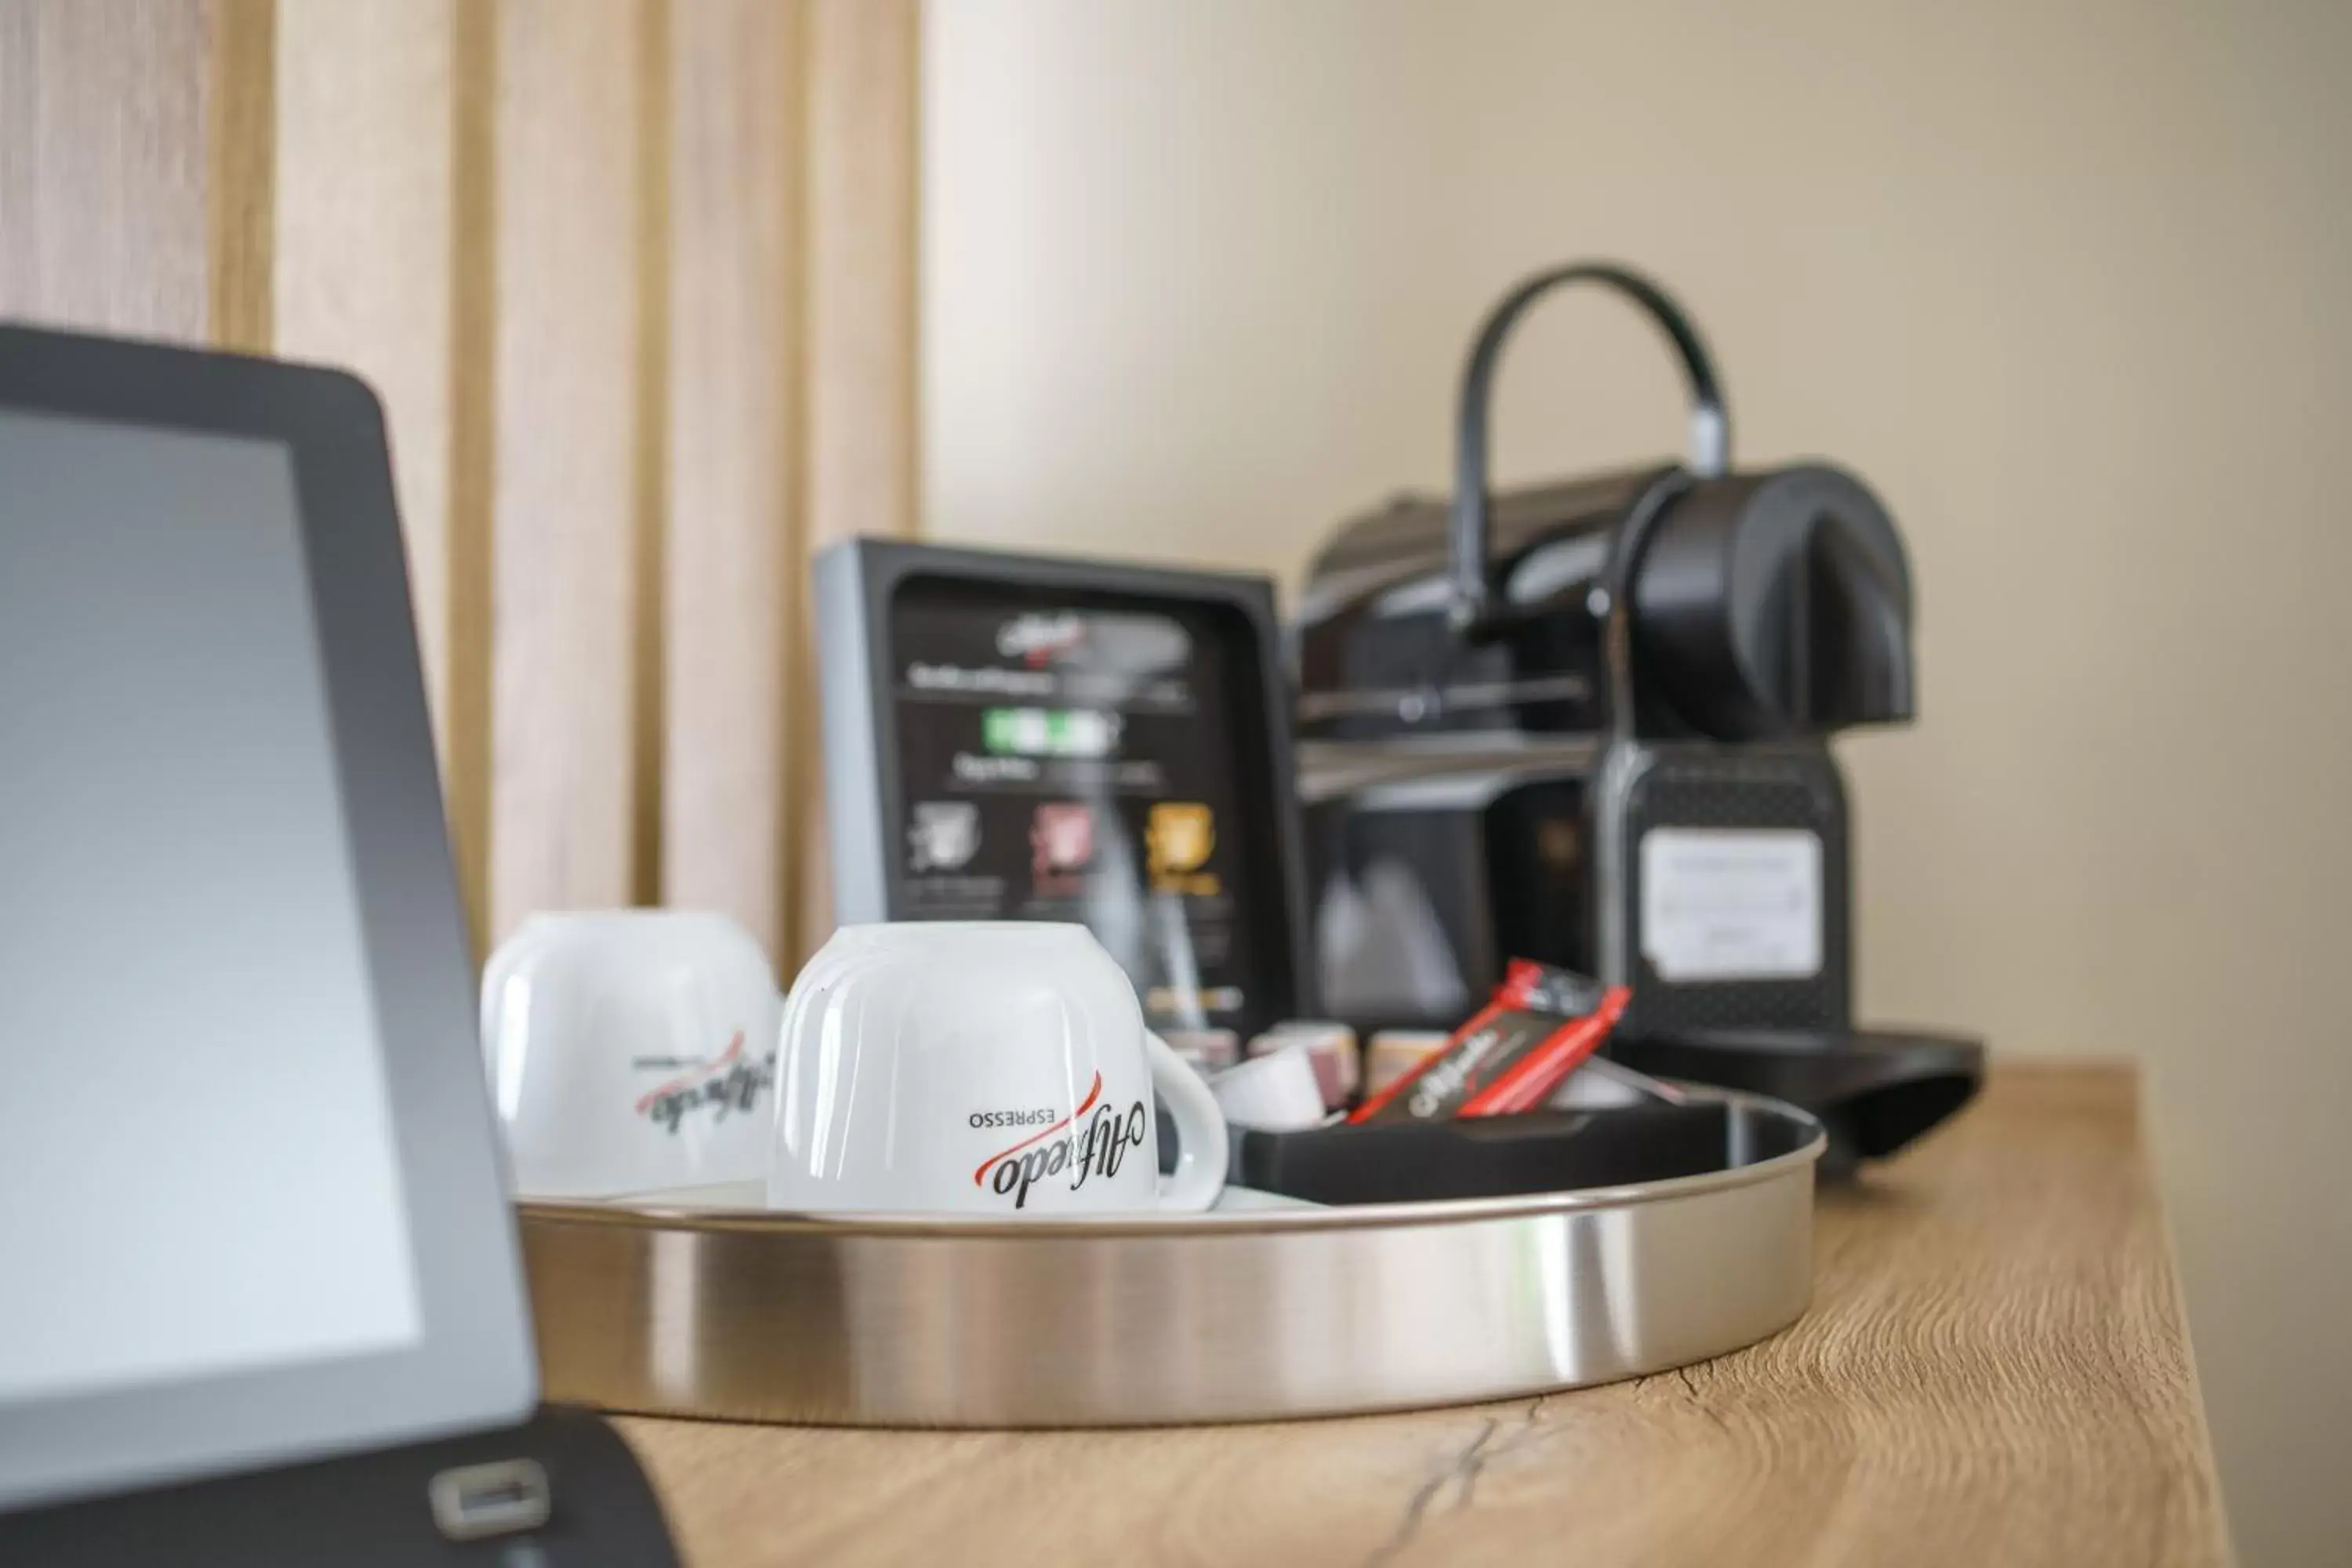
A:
767 921 1225 1220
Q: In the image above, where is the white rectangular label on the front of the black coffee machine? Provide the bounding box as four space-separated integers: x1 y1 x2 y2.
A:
1642 827 1820 980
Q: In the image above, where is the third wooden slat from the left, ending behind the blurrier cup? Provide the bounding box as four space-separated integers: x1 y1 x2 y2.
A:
489 0 642 940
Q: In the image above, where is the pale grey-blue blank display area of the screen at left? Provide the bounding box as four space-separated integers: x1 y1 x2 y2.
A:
0 412 423 1406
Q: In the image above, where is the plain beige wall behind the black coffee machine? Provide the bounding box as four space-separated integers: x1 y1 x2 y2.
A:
924 0 2352 1563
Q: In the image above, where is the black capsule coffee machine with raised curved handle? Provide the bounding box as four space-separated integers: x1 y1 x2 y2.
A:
1294 263 1980 1154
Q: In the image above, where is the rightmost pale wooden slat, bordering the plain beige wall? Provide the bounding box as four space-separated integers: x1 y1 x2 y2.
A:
795 0 920 954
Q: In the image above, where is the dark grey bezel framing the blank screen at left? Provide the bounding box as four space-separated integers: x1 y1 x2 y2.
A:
0 327 539 1509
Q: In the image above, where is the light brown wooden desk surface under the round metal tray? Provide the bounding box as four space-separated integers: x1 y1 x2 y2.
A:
621 1065 2227 1568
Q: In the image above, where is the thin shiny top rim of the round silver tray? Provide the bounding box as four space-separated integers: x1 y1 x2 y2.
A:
515 1088 1830 1241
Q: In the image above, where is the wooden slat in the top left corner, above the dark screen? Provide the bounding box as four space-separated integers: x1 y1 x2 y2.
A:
0 0 219 343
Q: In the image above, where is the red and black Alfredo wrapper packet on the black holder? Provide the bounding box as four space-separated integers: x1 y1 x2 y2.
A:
1348 959 1632 1121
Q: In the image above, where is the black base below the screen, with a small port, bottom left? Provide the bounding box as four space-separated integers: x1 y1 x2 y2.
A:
0 1406 677 1568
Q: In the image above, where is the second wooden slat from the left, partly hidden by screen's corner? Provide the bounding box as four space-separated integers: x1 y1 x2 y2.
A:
273 0 456 738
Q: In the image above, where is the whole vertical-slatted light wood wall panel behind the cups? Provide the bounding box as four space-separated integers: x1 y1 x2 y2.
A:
0 0 917 968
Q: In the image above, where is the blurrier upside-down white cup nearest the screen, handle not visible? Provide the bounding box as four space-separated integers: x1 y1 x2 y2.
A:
482 909 783 1196
